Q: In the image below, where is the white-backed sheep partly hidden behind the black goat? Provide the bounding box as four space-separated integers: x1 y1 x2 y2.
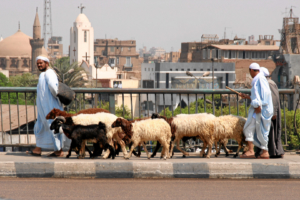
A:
71 113 127 159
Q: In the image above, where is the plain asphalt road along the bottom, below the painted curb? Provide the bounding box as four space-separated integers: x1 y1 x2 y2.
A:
0 178 300 200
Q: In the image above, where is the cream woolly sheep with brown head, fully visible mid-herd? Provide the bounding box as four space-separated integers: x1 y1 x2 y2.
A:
111 118 172 160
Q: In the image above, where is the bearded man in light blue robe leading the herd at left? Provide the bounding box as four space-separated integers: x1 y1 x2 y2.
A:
27 56 66 157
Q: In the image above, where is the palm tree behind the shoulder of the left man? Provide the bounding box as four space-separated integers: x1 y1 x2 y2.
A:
52 57 90 87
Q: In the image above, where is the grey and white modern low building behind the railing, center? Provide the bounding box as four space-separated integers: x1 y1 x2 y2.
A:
141 62 235 116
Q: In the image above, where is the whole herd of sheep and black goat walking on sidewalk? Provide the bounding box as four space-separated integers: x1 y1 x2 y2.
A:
46 108 247 159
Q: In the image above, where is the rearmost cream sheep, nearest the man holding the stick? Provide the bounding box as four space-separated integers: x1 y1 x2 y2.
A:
213 115 247 157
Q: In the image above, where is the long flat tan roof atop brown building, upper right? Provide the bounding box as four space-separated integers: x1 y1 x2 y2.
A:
210 45 279 51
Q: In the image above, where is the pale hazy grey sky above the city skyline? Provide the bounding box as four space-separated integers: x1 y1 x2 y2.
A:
0 0 300 53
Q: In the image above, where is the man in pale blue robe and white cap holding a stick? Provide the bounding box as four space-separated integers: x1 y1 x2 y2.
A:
240 63 273 159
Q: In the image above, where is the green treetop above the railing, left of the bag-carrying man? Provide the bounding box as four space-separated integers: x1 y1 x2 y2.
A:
9 73 38 87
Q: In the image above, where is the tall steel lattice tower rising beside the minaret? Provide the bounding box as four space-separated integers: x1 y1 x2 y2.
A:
43 0 52 49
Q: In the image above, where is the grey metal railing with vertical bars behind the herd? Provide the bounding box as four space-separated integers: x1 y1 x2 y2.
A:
0 87 295 149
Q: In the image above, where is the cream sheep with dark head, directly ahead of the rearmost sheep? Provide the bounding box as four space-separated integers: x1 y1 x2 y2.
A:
153 113 216 158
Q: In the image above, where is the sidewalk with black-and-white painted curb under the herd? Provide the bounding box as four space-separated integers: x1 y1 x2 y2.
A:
0 152 300 179
